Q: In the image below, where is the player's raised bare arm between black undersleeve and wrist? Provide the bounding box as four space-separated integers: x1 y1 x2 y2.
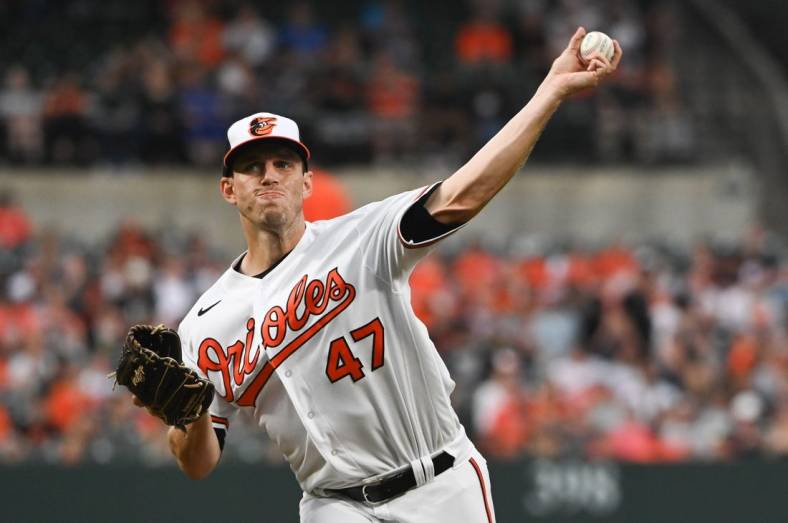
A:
425 81 562 223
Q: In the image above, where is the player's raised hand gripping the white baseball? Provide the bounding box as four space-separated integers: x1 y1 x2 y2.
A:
545 27 623 99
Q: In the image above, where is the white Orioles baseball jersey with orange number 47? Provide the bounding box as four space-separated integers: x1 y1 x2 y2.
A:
179 185 472 492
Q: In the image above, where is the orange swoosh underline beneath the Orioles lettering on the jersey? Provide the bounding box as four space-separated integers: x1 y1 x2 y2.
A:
237 269 356 407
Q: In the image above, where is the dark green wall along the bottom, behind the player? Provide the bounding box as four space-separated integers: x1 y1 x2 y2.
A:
6 461 788 523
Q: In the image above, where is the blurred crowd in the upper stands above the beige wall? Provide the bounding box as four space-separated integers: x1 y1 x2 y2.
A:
0 0 693 167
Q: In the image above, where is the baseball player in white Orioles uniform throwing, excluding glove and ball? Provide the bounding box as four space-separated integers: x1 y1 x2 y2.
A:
155 28 622 523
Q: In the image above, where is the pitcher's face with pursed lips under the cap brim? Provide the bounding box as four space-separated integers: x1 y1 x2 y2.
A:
222 143 312 230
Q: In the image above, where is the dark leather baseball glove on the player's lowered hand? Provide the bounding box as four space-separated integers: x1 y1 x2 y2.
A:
110 324 214 431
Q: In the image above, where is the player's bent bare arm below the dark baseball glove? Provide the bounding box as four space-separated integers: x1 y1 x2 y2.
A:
168 413 221 479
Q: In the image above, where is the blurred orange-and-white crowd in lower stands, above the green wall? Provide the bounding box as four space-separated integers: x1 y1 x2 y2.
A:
0 194 788 464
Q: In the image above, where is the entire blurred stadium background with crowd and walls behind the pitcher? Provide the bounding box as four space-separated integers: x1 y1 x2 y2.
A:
0 0 788 522
